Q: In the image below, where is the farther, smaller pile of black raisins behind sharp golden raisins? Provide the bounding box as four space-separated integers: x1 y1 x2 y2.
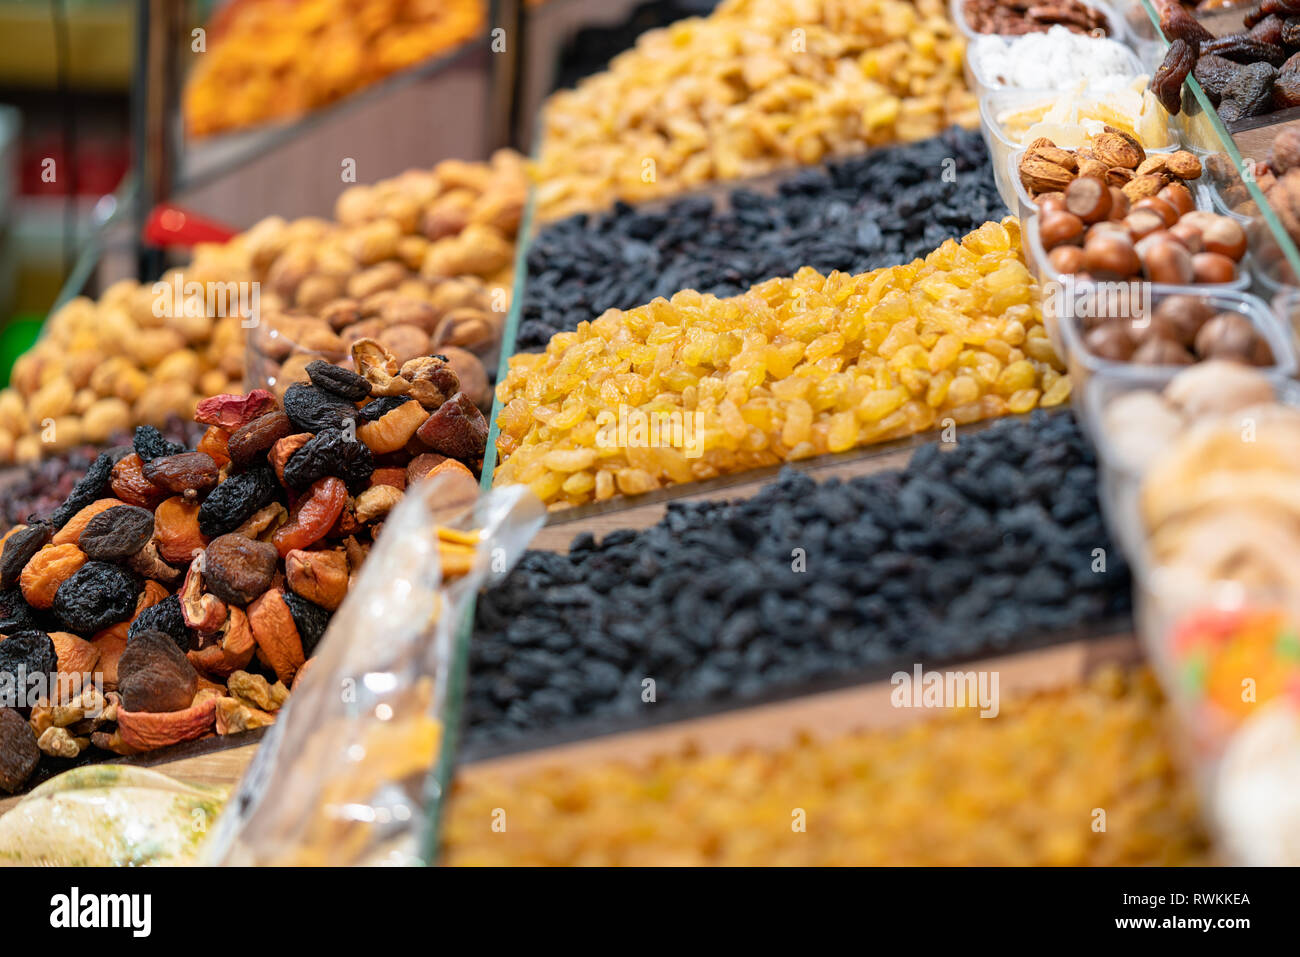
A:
516 129 1006 352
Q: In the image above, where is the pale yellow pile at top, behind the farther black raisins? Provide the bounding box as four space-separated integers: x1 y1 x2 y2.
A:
537 0 978 220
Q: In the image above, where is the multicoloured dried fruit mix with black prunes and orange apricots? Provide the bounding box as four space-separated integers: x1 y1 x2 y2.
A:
0 339 488 792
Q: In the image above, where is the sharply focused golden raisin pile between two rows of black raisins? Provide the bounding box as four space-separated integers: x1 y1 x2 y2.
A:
493 217 1070 507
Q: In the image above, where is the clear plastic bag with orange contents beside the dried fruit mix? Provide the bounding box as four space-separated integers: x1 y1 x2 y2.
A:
203 477 546 866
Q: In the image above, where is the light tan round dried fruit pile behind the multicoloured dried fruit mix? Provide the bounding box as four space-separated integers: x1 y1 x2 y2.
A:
0 150 528 465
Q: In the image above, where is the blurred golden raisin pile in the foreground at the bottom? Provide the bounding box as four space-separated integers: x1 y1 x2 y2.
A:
443 670 1209 866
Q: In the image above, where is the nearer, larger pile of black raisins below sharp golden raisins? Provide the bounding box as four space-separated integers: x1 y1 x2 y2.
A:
467 411 1130 746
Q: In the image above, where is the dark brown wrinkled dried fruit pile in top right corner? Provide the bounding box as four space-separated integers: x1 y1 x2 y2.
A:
1151 0 1300 122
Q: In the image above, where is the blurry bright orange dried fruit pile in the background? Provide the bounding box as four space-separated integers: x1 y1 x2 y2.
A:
185 0 485 137
